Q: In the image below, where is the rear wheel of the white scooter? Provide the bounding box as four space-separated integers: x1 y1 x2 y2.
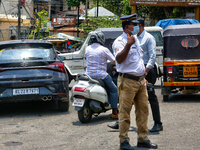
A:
78 103 92 123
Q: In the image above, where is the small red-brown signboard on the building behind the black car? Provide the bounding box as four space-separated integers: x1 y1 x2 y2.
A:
51 17 76 25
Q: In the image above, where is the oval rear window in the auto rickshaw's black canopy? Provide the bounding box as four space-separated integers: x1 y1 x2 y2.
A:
181 37 199 49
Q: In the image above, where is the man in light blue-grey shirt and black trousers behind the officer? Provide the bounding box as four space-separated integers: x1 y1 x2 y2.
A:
137 18 163 132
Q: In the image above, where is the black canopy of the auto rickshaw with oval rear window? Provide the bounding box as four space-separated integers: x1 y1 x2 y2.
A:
163 23 200 60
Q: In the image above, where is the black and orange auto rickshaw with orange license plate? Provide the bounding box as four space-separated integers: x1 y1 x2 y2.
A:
161 23 200 101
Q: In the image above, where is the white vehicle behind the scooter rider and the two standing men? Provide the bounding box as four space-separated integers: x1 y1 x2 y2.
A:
59 27 163 83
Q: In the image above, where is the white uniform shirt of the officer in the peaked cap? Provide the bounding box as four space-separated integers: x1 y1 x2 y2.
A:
112 32 145 76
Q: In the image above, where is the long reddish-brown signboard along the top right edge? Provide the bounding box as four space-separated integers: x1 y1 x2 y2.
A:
130 0 200 7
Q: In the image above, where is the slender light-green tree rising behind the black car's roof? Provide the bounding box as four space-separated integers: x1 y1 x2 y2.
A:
28 10 49 39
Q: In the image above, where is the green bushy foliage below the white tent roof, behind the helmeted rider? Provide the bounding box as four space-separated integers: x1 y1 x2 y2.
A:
79 16 122 39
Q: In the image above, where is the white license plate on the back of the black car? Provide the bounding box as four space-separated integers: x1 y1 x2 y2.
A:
13 88 39 95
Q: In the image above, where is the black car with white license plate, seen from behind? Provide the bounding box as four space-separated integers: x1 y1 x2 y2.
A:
0 40 69 111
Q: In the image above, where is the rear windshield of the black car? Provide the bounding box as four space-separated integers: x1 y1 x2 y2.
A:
0 45 54 61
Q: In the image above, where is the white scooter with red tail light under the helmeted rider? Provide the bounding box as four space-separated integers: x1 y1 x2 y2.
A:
71 74 116 123
